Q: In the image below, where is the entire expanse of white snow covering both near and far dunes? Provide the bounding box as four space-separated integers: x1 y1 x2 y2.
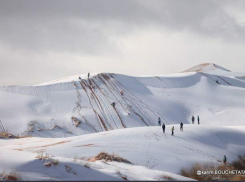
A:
0 63 245 180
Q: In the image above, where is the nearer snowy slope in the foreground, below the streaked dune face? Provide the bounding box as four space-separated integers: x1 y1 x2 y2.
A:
0 124 245 180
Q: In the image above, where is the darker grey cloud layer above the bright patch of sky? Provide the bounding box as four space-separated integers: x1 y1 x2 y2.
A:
0 0 245 55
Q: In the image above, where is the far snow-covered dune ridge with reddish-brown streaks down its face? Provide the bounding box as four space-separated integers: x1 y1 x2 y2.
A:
0 65 245 137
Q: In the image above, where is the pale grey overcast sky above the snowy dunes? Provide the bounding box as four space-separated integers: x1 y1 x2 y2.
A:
0 0 245 85
